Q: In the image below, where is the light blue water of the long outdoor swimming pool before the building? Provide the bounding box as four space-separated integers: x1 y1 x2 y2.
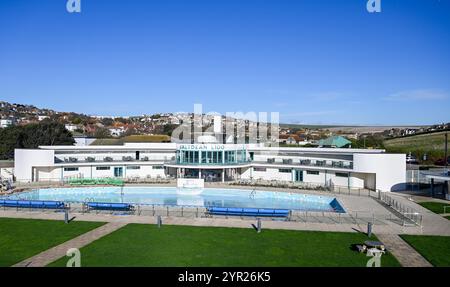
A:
2 187 344 212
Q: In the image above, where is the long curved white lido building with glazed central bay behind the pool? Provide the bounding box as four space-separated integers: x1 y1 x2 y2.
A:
14 143 406 191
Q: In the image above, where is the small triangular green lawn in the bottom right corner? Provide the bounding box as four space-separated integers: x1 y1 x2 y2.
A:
401 235 450 267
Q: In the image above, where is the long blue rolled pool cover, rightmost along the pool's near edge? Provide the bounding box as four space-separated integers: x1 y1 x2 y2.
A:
207 207 289 217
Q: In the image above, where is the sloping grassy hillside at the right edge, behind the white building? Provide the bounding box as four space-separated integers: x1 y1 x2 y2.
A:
384 132 450 163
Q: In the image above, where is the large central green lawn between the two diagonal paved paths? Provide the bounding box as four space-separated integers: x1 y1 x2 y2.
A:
50 224 399 267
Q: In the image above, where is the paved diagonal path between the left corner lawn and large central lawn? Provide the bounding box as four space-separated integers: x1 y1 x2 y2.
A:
13 222 126 267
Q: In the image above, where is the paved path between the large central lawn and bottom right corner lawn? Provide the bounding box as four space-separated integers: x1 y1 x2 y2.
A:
376 234 433 267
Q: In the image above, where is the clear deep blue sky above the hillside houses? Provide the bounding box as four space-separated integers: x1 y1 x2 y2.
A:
0 0 450 125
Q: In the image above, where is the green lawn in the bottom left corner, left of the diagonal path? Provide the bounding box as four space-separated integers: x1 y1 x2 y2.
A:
0 218 103 266
